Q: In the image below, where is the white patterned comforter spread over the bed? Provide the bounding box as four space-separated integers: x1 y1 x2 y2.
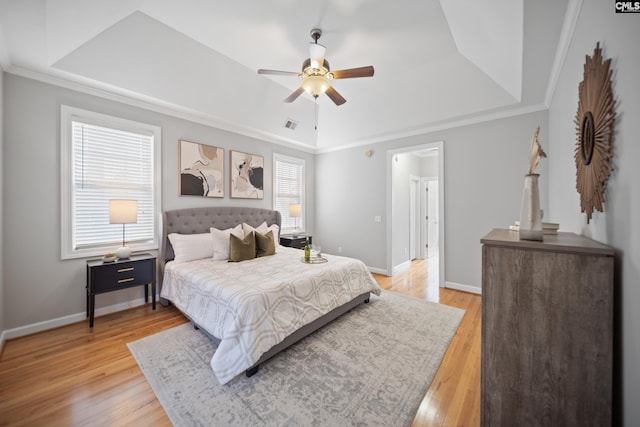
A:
161 246 380 384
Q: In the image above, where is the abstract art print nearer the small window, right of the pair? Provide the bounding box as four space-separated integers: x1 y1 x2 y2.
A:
230 150 264 199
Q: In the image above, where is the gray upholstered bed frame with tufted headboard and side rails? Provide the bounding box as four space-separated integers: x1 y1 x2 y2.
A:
158 207 370 377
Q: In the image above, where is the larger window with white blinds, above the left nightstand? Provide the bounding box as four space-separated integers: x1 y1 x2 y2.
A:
60 105 161 259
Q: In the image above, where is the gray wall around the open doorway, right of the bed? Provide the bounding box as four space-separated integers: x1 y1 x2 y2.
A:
314 111 553 291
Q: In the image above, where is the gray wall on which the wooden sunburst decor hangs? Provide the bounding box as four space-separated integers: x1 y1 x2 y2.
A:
549 0 640 427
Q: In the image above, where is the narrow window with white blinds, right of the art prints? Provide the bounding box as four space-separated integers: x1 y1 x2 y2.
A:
273 154 305 234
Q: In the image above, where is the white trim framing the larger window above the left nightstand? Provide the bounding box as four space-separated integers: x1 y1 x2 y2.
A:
60 104 162 259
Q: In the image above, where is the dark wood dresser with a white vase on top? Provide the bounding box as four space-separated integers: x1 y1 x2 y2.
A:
481 229 615 427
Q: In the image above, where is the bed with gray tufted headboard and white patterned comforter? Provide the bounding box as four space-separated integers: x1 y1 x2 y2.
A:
158 207 380 384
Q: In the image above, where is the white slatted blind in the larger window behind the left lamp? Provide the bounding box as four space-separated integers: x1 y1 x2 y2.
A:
71 121 154 250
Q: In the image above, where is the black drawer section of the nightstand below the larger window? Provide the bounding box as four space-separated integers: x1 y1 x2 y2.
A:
89 259 155 294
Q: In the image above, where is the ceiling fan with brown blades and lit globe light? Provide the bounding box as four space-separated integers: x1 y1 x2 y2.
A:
258 28 374 105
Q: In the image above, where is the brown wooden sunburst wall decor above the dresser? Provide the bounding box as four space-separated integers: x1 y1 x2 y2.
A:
575 43 616 224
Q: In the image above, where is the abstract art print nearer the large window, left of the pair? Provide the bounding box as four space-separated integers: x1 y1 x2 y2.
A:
178 140 224 197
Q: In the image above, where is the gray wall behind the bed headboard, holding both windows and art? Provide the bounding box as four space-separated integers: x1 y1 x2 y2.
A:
3 73 315 330
